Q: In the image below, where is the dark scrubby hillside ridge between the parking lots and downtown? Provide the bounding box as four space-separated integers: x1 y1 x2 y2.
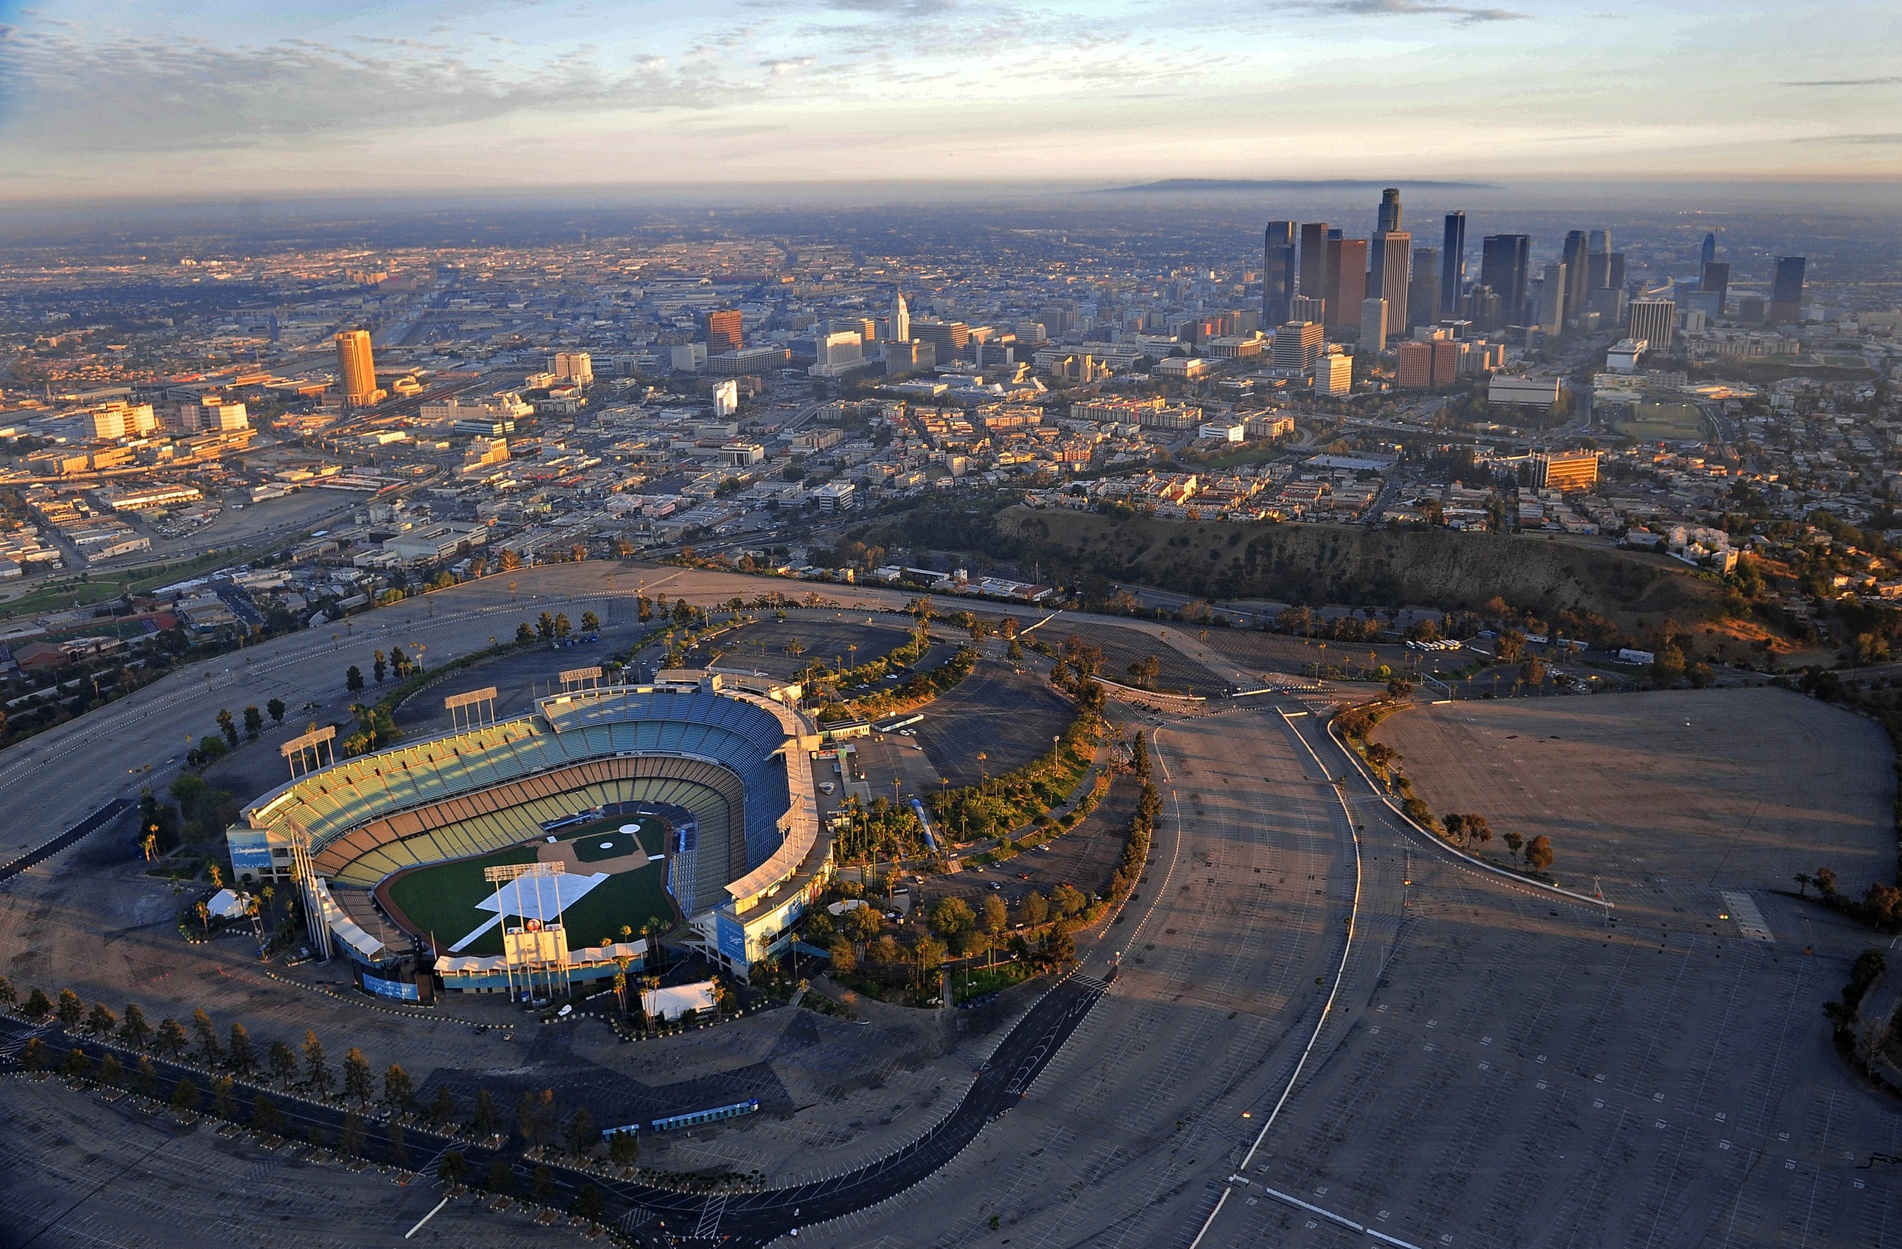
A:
991 508 1719 633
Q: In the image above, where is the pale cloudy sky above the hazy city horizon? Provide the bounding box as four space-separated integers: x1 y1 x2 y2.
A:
0 0 1902 200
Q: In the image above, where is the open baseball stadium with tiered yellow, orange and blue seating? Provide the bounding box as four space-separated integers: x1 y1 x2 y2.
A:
226 669 831 1002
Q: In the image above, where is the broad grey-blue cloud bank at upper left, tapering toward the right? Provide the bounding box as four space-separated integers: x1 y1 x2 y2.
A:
0 30 727 152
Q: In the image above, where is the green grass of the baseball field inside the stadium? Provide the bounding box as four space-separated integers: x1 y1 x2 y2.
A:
388 816 675 954
